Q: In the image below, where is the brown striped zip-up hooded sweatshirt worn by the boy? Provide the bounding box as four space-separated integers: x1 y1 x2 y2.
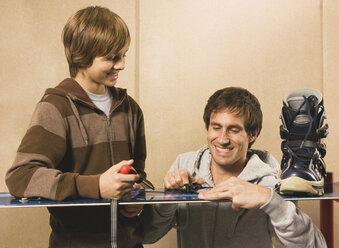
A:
6 79 146 247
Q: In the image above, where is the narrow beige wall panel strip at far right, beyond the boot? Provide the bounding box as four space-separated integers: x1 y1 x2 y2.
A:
323 0 339 247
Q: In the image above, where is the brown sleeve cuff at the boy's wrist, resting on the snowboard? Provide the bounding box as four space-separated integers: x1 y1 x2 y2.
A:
76 175 100 199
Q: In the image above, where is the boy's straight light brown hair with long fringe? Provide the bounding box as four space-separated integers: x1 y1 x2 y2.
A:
62 6 131 77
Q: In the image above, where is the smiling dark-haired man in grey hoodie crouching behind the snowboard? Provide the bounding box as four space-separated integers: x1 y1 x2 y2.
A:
142 87 326 248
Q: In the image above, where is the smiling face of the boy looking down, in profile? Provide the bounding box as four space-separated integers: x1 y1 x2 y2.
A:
75 44 129 94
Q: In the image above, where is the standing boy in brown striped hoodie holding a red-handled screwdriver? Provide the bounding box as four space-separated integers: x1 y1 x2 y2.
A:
6 6 146 248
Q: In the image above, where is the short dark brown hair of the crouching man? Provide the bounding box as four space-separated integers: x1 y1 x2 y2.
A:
203 87 263 147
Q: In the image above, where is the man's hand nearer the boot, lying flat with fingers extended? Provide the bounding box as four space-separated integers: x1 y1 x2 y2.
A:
199 177 271 210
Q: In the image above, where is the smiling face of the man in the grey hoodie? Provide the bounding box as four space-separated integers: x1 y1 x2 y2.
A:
207 109 250 171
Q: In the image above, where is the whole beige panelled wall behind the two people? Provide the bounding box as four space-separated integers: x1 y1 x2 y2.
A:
0 0 339 247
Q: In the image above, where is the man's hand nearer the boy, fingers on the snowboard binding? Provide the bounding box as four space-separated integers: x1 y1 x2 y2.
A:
164 169 205 189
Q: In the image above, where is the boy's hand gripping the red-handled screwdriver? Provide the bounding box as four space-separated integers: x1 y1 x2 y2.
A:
99 160 139 200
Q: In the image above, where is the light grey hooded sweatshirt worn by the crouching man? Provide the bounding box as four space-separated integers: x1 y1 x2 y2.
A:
142 146 326 248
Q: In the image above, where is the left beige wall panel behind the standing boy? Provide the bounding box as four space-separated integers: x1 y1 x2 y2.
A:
0 0 136 248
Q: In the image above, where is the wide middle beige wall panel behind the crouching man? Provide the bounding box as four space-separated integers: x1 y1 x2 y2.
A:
139 0 323 247
